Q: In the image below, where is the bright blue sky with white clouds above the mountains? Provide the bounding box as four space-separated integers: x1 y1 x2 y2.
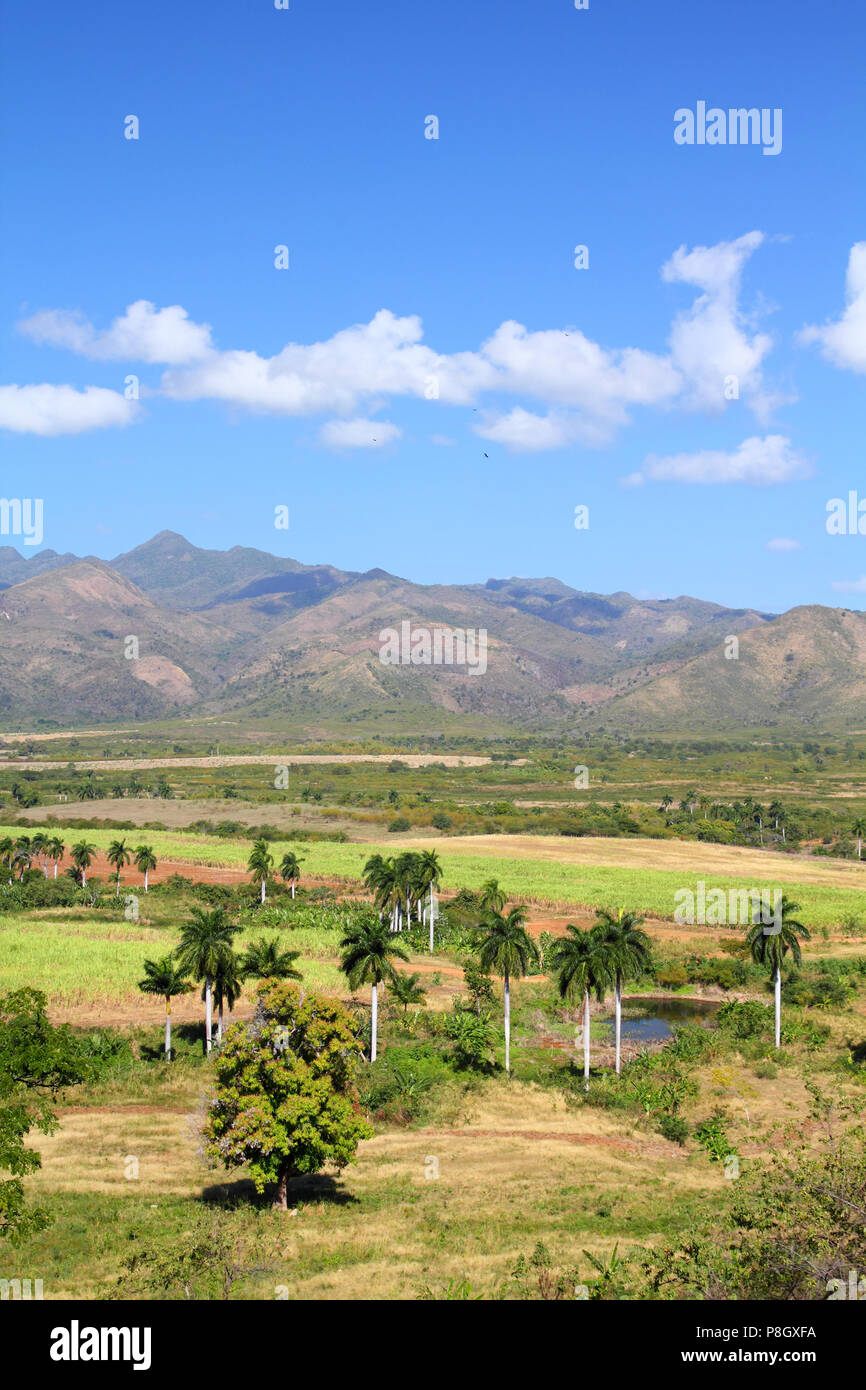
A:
0 0 866 610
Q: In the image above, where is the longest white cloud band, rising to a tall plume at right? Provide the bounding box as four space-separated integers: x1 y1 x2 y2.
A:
13 232 795 452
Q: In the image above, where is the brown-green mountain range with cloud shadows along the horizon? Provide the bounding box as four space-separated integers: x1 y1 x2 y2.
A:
0 531 866 733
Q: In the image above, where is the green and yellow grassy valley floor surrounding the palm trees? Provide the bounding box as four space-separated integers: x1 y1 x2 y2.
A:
0 734 866 1300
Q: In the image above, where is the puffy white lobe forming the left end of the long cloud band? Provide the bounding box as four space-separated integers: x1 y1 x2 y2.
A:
18 299 213 364
